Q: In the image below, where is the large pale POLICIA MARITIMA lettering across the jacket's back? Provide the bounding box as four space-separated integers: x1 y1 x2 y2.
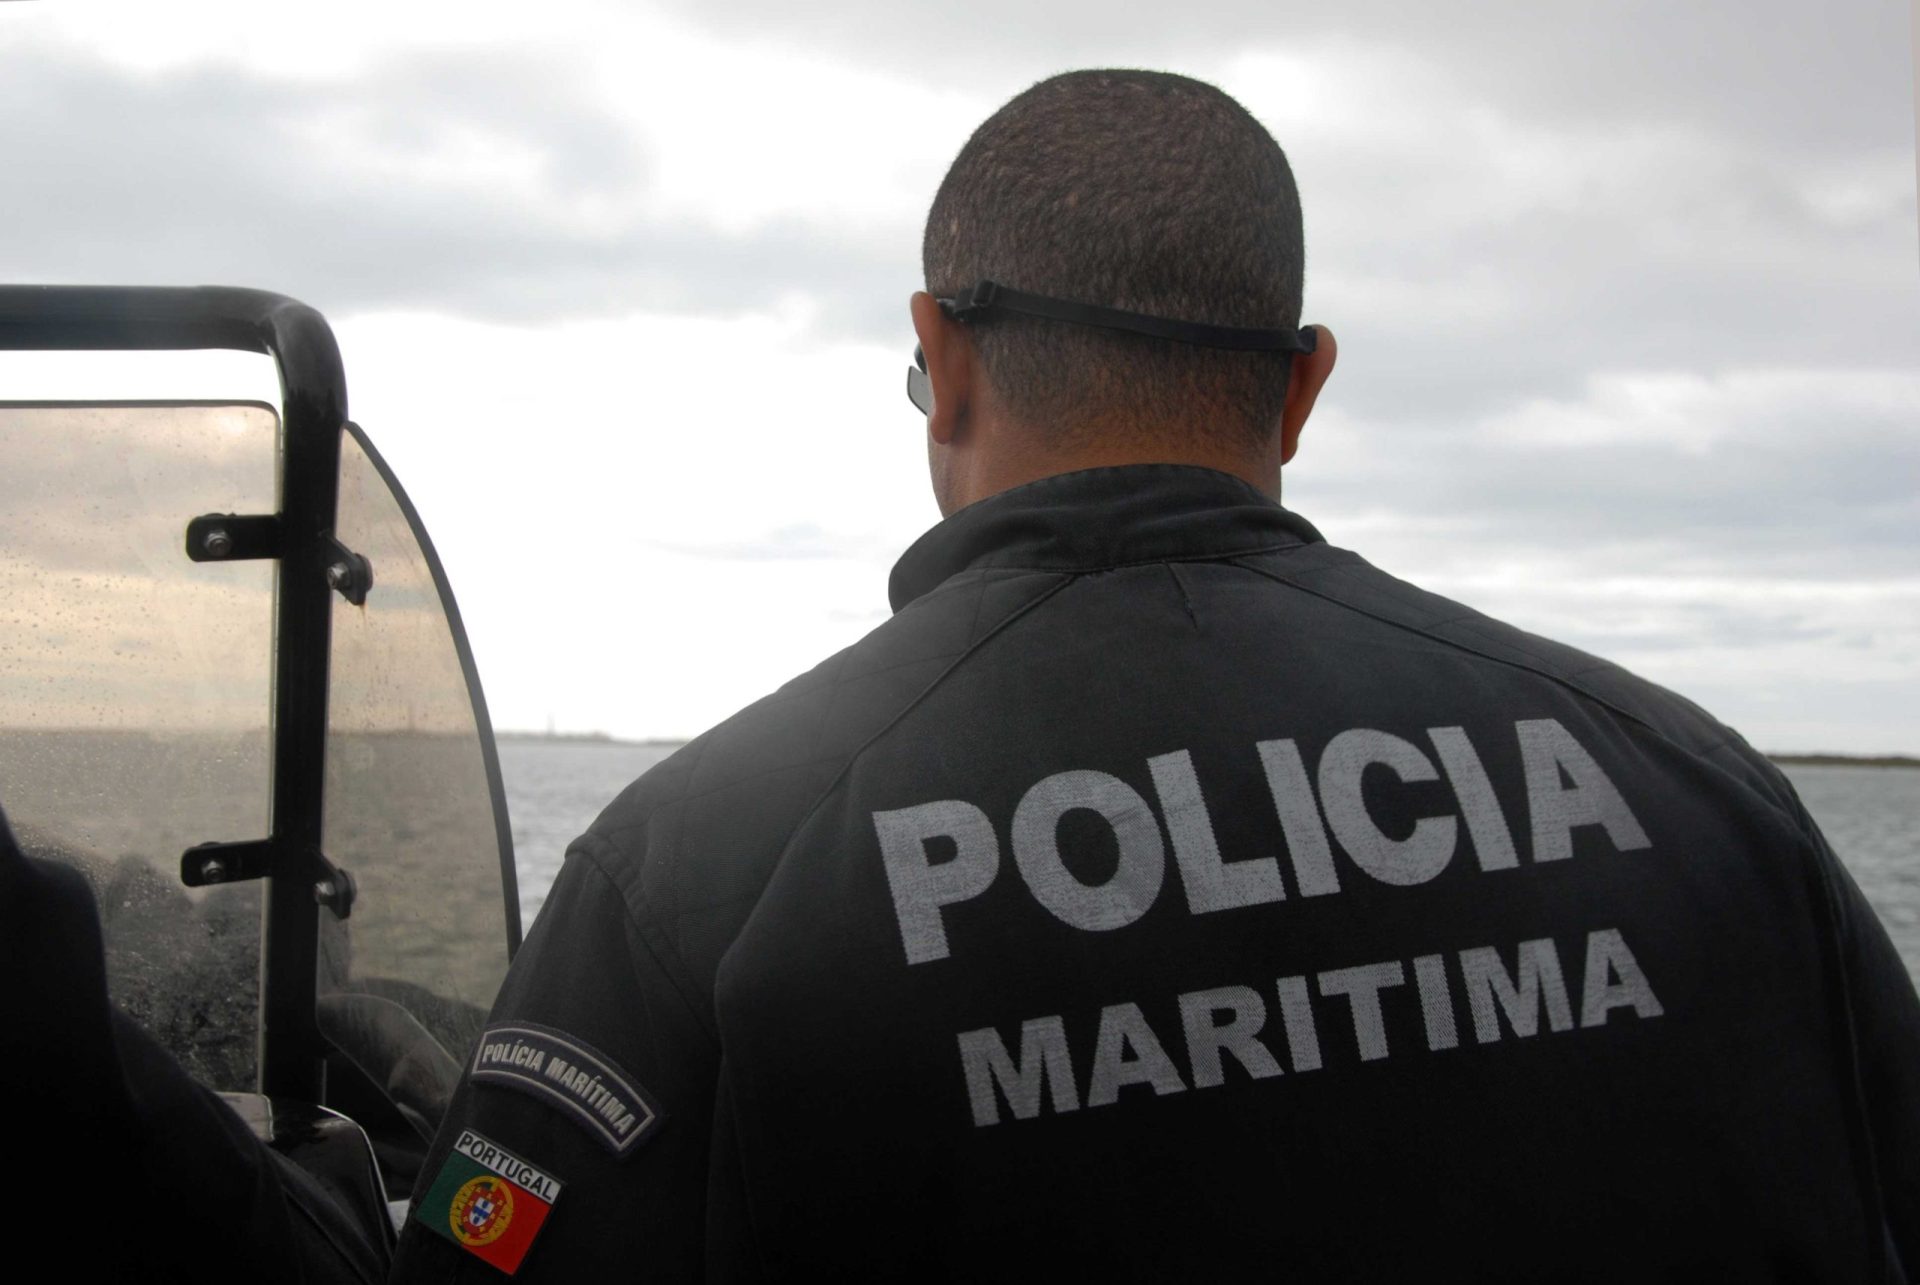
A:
874 718 1665 1126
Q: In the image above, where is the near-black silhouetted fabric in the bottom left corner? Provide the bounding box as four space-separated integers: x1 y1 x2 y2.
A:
0 795 384 1285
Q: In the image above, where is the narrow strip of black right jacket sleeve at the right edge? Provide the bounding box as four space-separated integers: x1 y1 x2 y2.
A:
1795 799 1920 1279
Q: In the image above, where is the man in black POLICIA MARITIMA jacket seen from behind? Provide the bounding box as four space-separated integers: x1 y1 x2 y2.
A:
399 71 1920 1281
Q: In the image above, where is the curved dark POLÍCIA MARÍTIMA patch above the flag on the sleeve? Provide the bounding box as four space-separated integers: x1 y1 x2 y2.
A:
467 1022 660 1160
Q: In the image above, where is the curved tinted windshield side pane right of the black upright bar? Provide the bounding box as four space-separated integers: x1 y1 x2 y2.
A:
321 428 518 1083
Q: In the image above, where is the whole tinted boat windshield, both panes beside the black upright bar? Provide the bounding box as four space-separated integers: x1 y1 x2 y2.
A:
0 401 518 1133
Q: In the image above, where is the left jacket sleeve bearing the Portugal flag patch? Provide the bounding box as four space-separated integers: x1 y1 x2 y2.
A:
392 836 718 1281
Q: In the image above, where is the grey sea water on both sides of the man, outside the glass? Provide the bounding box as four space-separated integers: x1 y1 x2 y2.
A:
499 738 1920 978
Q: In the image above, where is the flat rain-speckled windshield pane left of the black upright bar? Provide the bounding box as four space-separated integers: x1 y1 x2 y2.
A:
0 403 278 1089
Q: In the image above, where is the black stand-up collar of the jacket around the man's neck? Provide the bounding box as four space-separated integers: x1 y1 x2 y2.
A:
887 465 1321 611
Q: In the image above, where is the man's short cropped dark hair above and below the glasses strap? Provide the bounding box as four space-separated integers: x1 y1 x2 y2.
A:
922 71 1306 446
